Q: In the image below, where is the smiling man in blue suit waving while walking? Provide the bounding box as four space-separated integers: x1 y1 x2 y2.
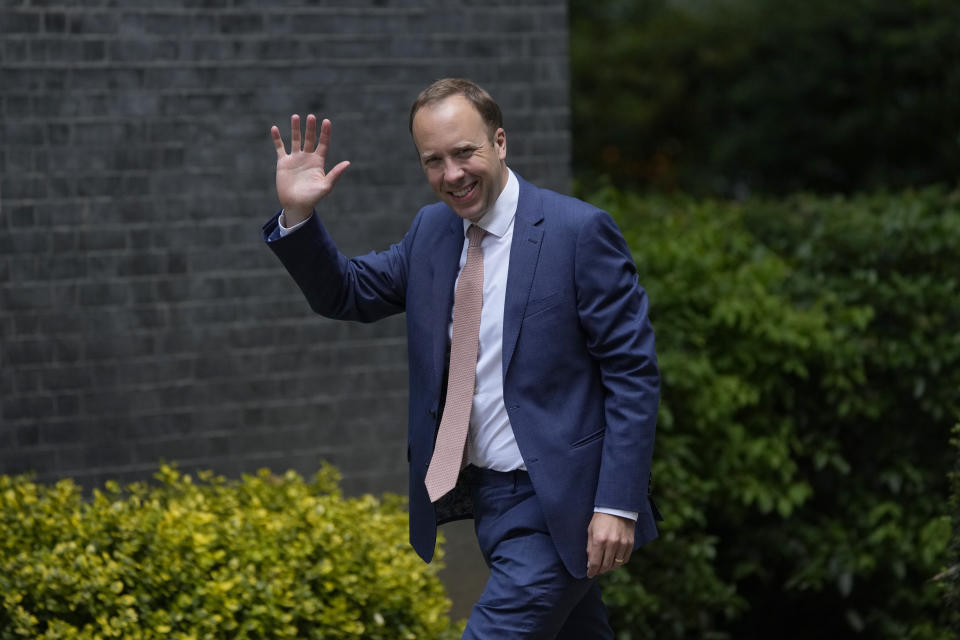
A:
263 78 659 640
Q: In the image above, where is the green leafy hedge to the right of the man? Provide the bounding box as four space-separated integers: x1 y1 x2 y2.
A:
590 184 960 640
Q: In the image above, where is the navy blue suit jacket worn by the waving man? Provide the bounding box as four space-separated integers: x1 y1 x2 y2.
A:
263 179 659 577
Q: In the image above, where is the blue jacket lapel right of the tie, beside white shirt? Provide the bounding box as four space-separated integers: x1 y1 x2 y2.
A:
503 176 543 379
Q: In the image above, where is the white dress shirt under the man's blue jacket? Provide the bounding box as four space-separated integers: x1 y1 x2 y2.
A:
279 169 638 520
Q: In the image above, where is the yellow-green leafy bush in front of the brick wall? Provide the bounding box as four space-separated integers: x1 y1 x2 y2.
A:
0 466 458 640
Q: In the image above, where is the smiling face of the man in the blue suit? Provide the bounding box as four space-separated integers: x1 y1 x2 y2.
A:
413 95 508 222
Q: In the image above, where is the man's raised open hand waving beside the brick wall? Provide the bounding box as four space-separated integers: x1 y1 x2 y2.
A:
270 113 350 226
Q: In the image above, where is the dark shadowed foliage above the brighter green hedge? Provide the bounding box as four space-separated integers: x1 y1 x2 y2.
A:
570 0 960 196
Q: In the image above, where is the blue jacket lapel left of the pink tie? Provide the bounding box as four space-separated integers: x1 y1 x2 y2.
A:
427 214 464 390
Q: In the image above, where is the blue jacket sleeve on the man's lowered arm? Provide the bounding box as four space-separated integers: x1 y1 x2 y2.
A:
575 210 660 512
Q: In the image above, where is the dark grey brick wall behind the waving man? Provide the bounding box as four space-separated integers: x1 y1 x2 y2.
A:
0 0 569 500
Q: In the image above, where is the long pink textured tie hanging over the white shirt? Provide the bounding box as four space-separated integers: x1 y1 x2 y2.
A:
425 225 486 502
